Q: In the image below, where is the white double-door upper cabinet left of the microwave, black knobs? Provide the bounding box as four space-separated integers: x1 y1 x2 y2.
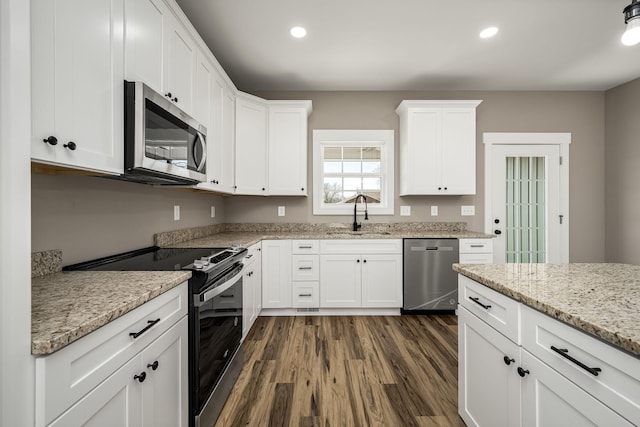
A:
31 0 125 174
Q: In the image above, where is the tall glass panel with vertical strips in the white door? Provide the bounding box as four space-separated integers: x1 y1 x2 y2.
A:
505 157 547 263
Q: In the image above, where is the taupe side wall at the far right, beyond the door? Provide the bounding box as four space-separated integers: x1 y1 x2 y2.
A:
605 79 640 265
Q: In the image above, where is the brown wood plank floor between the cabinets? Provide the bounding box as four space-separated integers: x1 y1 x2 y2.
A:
215 315 464 427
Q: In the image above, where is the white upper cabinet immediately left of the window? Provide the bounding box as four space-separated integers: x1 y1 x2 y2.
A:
268 101 311 196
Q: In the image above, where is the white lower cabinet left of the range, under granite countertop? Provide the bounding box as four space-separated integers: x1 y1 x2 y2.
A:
36 283 189 427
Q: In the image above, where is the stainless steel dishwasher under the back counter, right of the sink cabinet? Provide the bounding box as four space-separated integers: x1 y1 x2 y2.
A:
403 239 459 311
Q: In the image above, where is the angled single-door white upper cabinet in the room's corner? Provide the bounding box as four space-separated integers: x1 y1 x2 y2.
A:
235 93 268 195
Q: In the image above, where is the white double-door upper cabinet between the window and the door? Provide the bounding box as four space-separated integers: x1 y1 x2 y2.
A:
396 100 482 196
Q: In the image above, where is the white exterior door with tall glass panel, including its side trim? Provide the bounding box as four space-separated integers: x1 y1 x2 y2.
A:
485 134 568 263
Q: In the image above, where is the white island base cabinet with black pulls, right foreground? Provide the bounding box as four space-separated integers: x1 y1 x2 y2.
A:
458 276 640 427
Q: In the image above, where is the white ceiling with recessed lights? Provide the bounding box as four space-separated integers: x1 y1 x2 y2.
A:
177 0 640 91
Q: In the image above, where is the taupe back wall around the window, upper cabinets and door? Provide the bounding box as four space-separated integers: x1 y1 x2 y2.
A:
230 91 605 262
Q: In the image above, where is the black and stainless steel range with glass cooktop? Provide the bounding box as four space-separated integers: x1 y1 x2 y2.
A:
64 246 247 427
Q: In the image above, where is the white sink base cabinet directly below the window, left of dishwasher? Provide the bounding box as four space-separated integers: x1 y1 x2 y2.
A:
320 239 402 308
